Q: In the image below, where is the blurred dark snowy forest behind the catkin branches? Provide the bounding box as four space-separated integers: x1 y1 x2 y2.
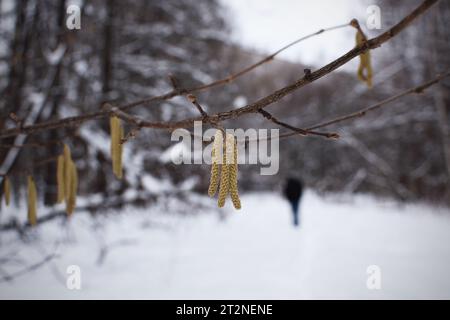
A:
0 0 450 215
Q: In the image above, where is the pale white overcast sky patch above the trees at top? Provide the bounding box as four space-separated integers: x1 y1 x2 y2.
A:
222 0 367 67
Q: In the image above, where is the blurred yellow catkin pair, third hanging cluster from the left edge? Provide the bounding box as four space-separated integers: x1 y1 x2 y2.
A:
56 144 78 216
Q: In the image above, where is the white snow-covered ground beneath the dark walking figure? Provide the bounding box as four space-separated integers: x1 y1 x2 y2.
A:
0 192 450 299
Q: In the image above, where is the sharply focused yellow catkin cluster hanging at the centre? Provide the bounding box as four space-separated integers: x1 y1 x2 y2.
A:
208 130 241 209
